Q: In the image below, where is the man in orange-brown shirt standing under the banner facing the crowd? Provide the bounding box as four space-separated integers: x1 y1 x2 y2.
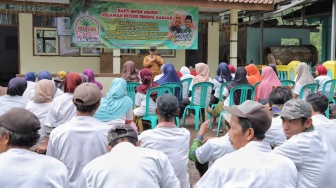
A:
143 46 164 78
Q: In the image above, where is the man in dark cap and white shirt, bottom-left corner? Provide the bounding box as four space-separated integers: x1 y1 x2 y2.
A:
0 108 69 187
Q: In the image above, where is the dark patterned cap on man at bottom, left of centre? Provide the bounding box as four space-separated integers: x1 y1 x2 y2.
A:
107 125 138 144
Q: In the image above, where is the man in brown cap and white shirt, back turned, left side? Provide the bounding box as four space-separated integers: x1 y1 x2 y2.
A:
47 83 110 187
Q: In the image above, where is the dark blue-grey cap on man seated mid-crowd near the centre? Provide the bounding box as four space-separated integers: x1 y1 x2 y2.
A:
156 93 178 117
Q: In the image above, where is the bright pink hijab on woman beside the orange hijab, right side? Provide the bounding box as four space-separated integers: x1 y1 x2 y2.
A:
256 67 281 100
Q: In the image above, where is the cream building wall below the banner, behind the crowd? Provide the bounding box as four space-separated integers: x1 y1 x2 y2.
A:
19 13 185 74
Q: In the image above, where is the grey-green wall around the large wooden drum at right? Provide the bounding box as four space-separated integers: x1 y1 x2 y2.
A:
246 27 310 65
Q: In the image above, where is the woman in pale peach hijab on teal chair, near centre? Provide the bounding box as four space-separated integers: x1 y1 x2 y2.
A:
179 63 212 118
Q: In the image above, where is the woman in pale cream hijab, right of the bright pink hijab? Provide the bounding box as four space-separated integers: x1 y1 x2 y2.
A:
293 63 315 99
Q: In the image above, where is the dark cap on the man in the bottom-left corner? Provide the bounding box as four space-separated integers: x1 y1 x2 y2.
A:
0 108 41 134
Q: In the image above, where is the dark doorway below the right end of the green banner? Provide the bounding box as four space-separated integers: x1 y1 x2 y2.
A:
185 32 208 68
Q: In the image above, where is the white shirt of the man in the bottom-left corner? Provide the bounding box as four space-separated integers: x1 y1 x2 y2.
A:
0 148 69 188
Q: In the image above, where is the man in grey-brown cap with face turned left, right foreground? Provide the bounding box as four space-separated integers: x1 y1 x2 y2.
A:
195 100 297 188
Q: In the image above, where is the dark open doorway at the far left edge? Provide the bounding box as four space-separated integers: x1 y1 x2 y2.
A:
0 26 19 87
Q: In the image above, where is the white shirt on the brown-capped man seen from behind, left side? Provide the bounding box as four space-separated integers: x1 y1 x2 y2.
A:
47 116 111 188
